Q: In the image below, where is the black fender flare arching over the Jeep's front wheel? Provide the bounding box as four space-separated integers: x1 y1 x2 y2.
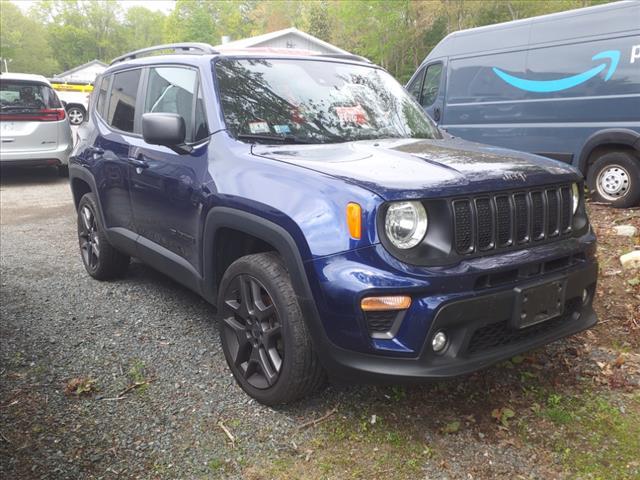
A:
201 207 329 351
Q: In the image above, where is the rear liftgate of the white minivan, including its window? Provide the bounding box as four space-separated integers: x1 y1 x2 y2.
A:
0 79 65 153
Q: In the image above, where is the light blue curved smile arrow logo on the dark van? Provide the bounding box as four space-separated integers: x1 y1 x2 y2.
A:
493 50 620 93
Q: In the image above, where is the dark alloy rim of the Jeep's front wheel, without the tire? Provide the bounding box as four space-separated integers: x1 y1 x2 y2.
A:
222 274 285 389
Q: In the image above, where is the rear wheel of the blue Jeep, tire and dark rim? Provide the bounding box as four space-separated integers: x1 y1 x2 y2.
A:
78 193 129 280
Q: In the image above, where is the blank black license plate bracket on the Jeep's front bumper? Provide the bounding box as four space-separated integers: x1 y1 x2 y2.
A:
511 277 567 330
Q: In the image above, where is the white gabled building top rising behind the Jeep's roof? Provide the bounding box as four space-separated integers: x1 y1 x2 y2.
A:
215 27 349 55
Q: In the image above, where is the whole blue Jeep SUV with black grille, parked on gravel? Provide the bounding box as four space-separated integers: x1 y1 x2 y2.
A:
70 44 597 404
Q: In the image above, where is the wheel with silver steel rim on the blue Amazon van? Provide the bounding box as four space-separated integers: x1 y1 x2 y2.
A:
587 152 640 208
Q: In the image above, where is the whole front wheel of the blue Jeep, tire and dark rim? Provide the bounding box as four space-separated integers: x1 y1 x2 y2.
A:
218 253 324 405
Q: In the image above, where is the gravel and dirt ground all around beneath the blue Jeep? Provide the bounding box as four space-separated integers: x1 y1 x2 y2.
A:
0 170 640 480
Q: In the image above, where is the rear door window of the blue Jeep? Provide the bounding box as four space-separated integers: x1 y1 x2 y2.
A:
107 69 142 132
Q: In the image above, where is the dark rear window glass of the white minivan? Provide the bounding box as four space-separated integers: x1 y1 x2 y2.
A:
0 80 62 113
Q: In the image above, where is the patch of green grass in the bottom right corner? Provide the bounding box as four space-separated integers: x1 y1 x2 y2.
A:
539 394 640 479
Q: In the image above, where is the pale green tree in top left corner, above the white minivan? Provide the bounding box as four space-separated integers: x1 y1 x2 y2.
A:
0 1 59 76
